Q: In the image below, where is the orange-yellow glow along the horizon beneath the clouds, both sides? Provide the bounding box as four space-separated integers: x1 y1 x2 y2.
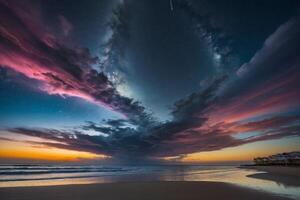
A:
0 137 300 163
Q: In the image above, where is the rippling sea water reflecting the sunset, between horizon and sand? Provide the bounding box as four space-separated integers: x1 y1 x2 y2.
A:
0 166 300 199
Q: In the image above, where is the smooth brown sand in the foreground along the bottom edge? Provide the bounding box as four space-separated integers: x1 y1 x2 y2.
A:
0 181 288 200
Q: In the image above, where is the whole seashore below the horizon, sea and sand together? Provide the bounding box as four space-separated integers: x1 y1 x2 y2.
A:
0 165 300 200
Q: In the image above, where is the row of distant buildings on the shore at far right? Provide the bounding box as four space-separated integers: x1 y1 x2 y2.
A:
253 151 300 165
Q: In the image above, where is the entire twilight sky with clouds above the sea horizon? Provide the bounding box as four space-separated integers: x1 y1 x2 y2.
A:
0 0 300 163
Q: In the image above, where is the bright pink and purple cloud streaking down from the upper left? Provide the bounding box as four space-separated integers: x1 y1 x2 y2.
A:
0 1 146 120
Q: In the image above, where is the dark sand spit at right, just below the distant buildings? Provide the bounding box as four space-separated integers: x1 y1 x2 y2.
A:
242 166 300 187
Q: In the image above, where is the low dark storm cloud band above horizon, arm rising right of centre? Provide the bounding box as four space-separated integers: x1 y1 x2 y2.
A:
5 74 300 158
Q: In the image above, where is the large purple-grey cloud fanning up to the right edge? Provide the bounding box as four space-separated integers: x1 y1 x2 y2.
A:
210 18 300 123
